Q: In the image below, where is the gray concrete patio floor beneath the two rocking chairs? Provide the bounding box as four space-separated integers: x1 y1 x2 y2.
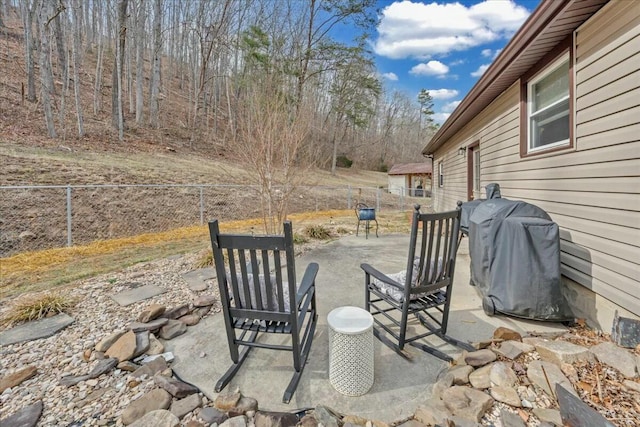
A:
166 234 565 422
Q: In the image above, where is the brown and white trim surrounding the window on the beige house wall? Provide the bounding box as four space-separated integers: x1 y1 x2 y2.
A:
520 34 575 158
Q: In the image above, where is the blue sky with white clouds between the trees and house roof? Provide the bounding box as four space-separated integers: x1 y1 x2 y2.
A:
370 0 540 123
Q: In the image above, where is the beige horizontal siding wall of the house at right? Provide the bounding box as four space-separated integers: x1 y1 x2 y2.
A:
434 1 640 329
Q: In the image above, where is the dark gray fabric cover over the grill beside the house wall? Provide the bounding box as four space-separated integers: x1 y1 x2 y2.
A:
469 199 573 321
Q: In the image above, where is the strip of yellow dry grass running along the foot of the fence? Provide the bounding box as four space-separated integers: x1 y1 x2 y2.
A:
0 210 409 303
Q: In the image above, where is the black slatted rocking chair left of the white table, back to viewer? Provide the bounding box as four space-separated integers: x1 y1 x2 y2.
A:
209 220 318 403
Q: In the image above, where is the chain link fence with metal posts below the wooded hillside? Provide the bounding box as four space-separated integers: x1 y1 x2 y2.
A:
0 185 428 258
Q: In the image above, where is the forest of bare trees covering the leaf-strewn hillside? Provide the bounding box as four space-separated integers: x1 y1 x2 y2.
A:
0 0 435 171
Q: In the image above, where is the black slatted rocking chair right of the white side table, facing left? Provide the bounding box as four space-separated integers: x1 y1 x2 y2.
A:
360 202 475 361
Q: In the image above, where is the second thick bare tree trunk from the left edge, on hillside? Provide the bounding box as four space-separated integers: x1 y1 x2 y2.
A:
38 0 57 138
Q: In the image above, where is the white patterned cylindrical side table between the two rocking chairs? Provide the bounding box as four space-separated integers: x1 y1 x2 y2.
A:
327 306 374 396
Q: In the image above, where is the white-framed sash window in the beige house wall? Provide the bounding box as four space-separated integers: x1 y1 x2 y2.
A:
526 53 571 153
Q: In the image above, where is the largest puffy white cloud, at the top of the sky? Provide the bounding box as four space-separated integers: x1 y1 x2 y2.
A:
374 0 530 59
